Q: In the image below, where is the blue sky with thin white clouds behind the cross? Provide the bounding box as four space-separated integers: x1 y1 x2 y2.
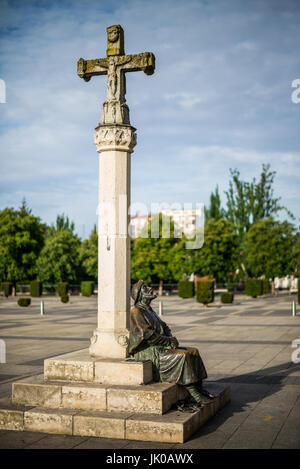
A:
0 0 300 237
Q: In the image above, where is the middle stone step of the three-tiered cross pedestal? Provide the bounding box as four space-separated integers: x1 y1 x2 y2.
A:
12 375 178 415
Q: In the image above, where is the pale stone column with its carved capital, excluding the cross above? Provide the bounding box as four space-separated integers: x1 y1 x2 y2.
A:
89 124 136 359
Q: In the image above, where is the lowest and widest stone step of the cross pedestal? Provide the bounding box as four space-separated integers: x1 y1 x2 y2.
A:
0 383 230 443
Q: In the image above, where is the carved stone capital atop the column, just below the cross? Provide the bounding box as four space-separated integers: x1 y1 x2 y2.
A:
94 124 136 153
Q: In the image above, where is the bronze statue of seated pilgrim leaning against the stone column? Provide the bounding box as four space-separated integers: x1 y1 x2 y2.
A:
129 280 214 406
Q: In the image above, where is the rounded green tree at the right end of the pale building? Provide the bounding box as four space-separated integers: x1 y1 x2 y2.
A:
192 218 238 283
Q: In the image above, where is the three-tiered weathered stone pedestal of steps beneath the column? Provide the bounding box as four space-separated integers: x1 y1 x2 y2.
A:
0 349 230 443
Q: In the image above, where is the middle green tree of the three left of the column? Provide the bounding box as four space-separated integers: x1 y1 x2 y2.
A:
37 216 80 283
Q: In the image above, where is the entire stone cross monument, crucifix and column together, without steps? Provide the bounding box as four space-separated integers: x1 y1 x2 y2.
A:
77 25 155 359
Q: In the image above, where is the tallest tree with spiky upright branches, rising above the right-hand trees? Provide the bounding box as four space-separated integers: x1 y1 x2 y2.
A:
225 164 293 242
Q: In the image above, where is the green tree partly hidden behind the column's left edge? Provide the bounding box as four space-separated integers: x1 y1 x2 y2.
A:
79 226 98 280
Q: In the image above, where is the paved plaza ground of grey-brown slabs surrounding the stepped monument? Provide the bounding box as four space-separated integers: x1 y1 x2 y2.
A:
0 294 300 450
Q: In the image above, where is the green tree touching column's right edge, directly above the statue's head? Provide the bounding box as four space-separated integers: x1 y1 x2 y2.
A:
131 214 177 283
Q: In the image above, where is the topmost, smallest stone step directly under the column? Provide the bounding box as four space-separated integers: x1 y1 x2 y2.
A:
44 349 152 386
